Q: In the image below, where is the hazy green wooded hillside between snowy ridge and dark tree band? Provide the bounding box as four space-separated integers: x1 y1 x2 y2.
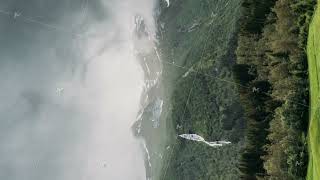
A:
158 0 244 180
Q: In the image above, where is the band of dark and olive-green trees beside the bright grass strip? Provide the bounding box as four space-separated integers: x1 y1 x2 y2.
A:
233 0 316 180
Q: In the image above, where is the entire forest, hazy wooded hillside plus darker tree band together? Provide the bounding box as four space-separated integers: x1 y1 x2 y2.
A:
159 0 316 180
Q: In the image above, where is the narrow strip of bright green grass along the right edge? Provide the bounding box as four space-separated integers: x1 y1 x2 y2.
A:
307 1 320 180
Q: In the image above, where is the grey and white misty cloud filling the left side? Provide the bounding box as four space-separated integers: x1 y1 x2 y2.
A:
0 0 155 180
